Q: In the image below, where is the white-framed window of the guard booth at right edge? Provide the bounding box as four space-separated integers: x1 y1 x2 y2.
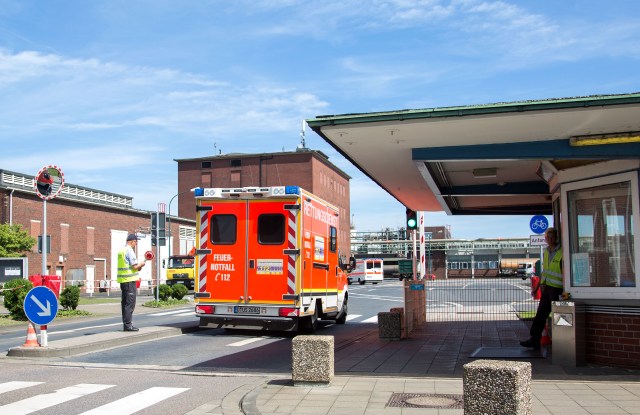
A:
565 175 637 289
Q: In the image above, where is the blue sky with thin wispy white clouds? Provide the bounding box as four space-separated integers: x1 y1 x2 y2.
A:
0 0 640 238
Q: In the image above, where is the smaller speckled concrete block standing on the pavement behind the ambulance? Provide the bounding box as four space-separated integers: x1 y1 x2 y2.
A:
291 336 334 385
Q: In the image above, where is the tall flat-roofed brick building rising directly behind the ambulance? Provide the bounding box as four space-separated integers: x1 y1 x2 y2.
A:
176 149 351 256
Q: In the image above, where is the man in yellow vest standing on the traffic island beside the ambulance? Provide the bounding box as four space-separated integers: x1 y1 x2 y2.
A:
118 233 146 331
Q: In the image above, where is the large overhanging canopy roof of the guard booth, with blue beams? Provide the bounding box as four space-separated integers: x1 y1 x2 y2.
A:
306 93 640 214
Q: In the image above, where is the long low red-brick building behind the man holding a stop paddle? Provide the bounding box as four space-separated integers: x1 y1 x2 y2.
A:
0 170 195 292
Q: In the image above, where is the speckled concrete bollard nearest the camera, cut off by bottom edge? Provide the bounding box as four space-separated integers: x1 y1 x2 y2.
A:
463 360 533 415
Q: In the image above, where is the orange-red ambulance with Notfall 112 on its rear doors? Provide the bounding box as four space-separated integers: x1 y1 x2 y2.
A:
194 186 349 332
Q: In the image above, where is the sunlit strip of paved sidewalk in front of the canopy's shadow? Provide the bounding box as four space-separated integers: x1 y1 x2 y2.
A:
239 376 640 415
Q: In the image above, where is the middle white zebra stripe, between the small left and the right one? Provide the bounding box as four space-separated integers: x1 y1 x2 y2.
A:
0 383 115 415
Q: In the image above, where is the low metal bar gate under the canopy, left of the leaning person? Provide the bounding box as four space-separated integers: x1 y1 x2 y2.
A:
425 277 538 321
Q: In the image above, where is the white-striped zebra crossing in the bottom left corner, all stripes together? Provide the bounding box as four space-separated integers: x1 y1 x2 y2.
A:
0 381 190 415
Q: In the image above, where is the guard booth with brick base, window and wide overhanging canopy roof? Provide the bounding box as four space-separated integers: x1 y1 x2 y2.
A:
307 93 640 369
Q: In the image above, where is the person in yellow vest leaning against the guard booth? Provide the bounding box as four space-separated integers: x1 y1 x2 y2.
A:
520 228 563 349
